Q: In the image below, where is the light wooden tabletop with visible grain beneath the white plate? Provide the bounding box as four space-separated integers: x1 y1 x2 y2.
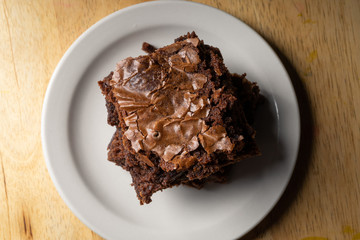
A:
0 0 360 240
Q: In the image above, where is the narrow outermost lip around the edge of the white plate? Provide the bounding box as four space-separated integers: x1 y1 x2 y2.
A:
41 0 301 238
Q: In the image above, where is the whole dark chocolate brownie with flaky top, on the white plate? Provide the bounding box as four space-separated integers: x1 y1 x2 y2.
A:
98 32 260 204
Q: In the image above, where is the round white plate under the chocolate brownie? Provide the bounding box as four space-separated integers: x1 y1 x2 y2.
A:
42 1 300 239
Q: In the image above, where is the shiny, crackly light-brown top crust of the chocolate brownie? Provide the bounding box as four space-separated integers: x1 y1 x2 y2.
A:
110 38 234 169
